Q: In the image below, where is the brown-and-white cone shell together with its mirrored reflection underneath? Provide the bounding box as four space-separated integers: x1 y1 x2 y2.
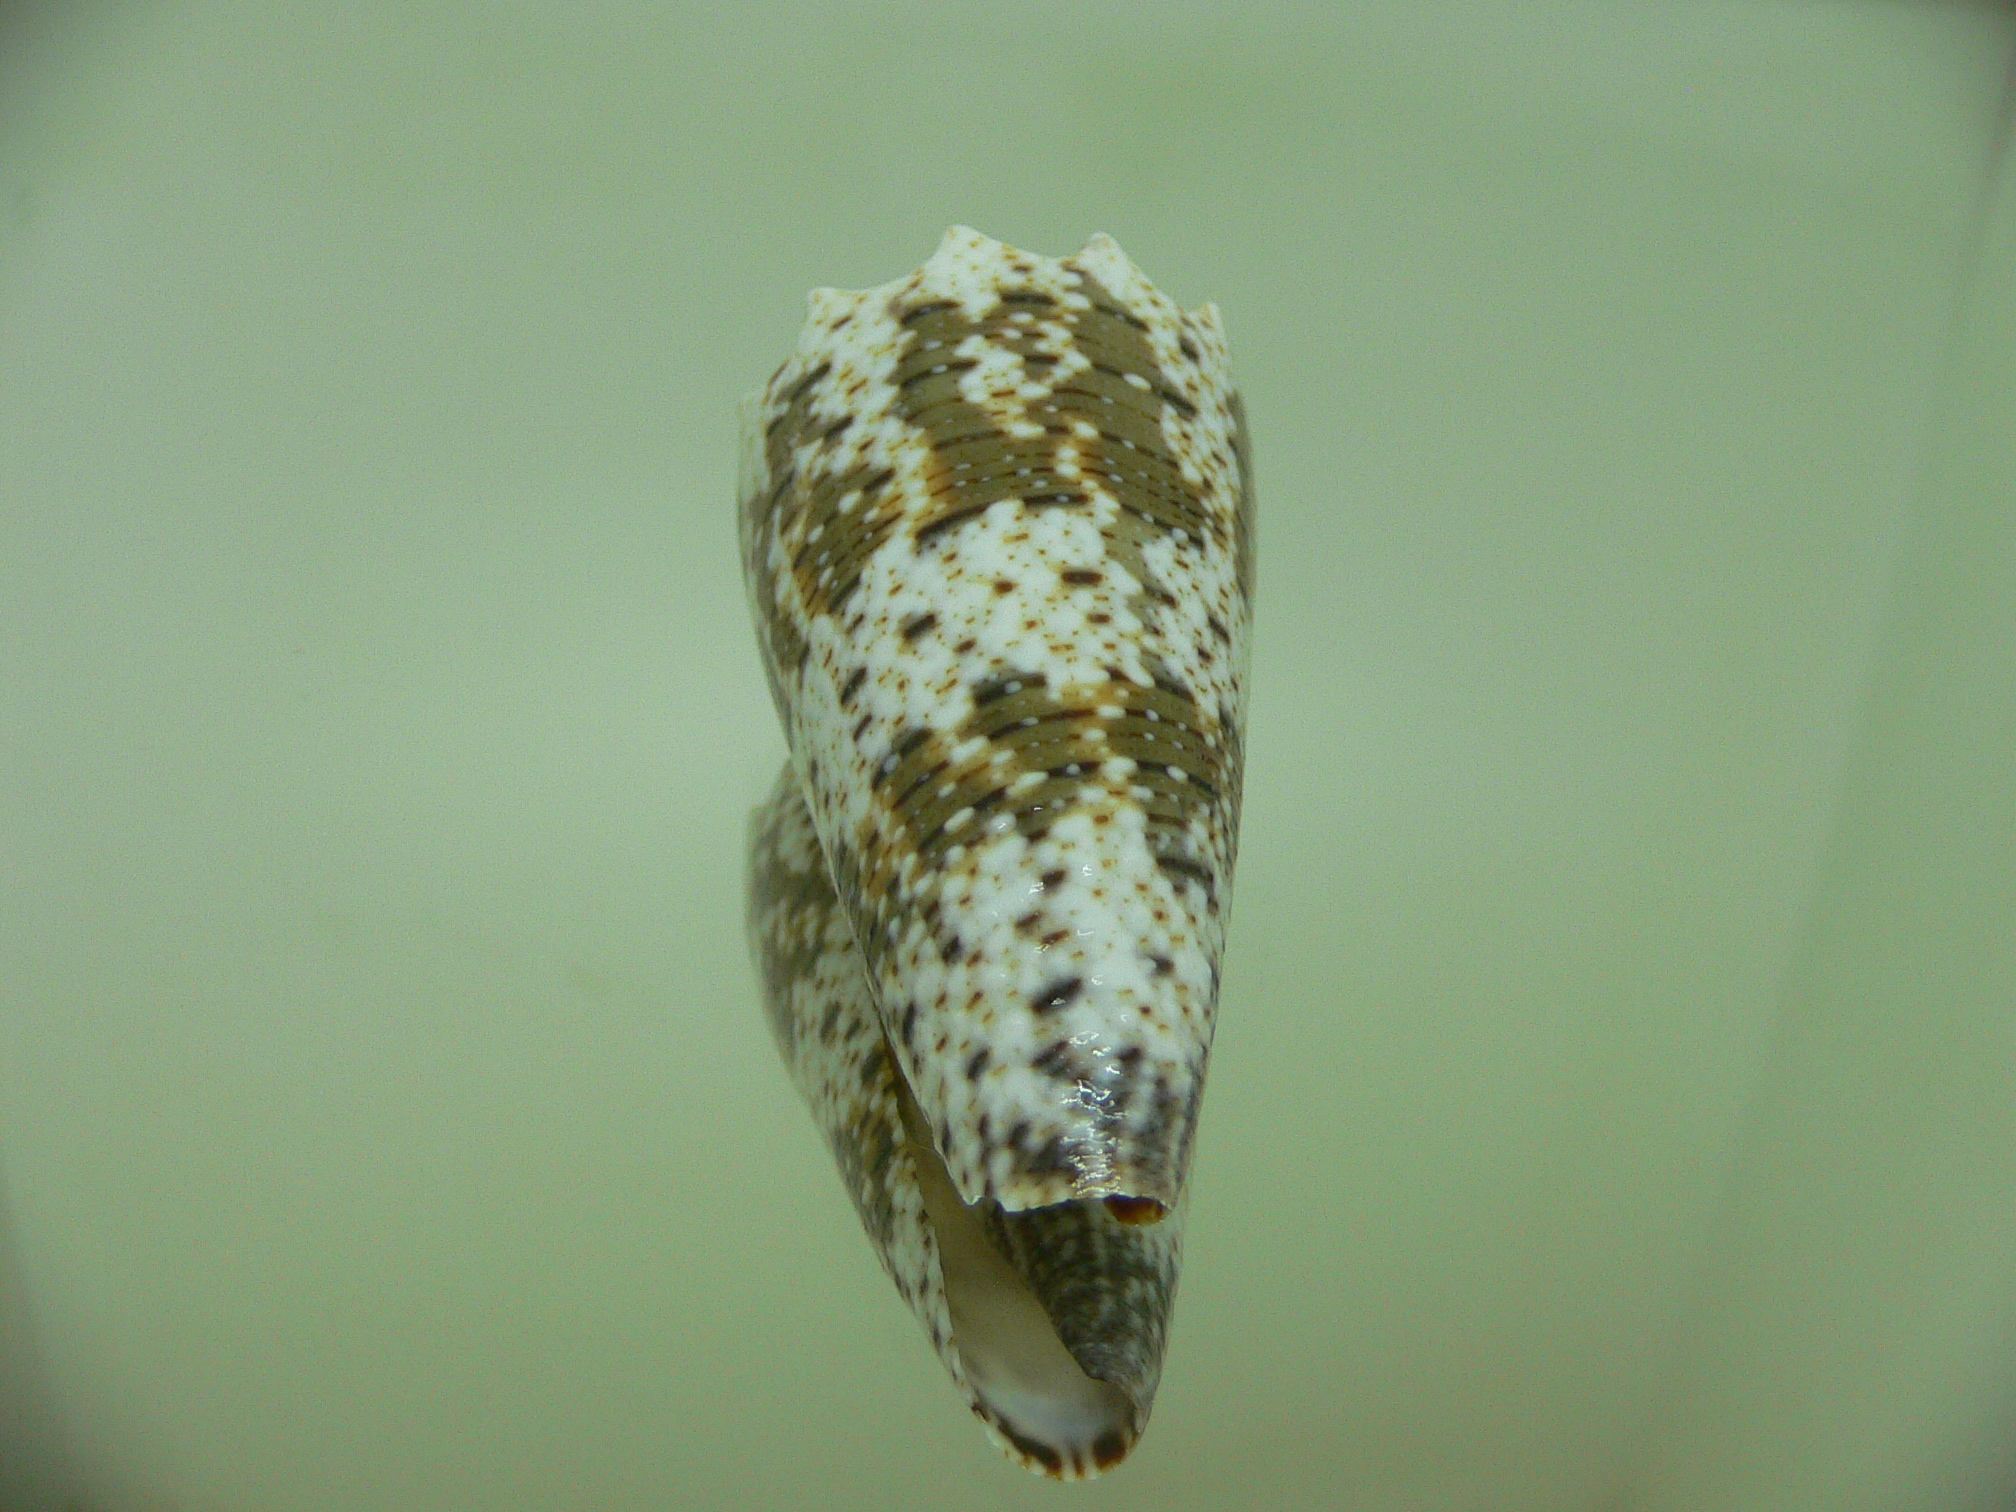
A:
742 228 1254 1478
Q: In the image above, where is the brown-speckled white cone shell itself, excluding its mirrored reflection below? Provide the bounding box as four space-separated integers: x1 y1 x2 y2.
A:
742 230 1252 1210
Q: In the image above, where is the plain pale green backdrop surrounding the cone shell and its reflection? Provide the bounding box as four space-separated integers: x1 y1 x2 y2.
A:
0 0 2016 1512
